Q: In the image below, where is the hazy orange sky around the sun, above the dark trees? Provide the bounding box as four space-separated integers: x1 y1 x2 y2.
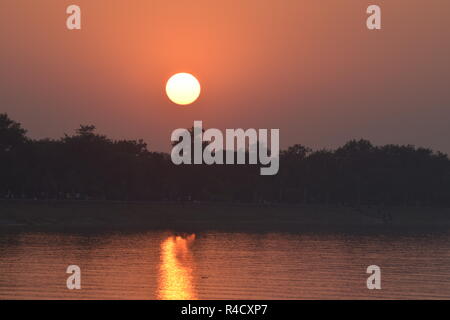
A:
0 0 450 152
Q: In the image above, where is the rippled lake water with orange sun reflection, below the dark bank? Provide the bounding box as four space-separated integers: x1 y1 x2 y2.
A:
0 232 450 299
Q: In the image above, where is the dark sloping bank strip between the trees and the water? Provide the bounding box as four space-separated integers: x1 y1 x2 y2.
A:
0 201 450 232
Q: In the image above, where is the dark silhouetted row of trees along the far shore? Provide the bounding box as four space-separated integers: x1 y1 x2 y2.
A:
0 114 450 206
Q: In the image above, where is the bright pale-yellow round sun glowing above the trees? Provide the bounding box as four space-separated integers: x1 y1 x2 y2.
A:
166 73 201 106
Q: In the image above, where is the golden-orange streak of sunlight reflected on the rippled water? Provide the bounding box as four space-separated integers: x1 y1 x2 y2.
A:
158 234 197 300
